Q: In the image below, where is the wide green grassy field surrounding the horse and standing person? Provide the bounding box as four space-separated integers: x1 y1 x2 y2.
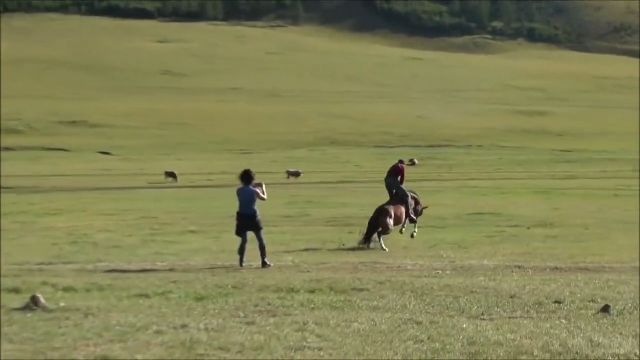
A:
1 15 640 359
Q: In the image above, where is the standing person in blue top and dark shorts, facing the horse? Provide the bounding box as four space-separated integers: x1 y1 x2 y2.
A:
236 169 271 268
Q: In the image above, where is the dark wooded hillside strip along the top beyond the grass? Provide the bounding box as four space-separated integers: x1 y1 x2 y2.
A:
0 0 640 57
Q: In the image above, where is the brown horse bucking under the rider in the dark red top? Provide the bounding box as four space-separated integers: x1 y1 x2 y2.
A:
360 190 428 251
